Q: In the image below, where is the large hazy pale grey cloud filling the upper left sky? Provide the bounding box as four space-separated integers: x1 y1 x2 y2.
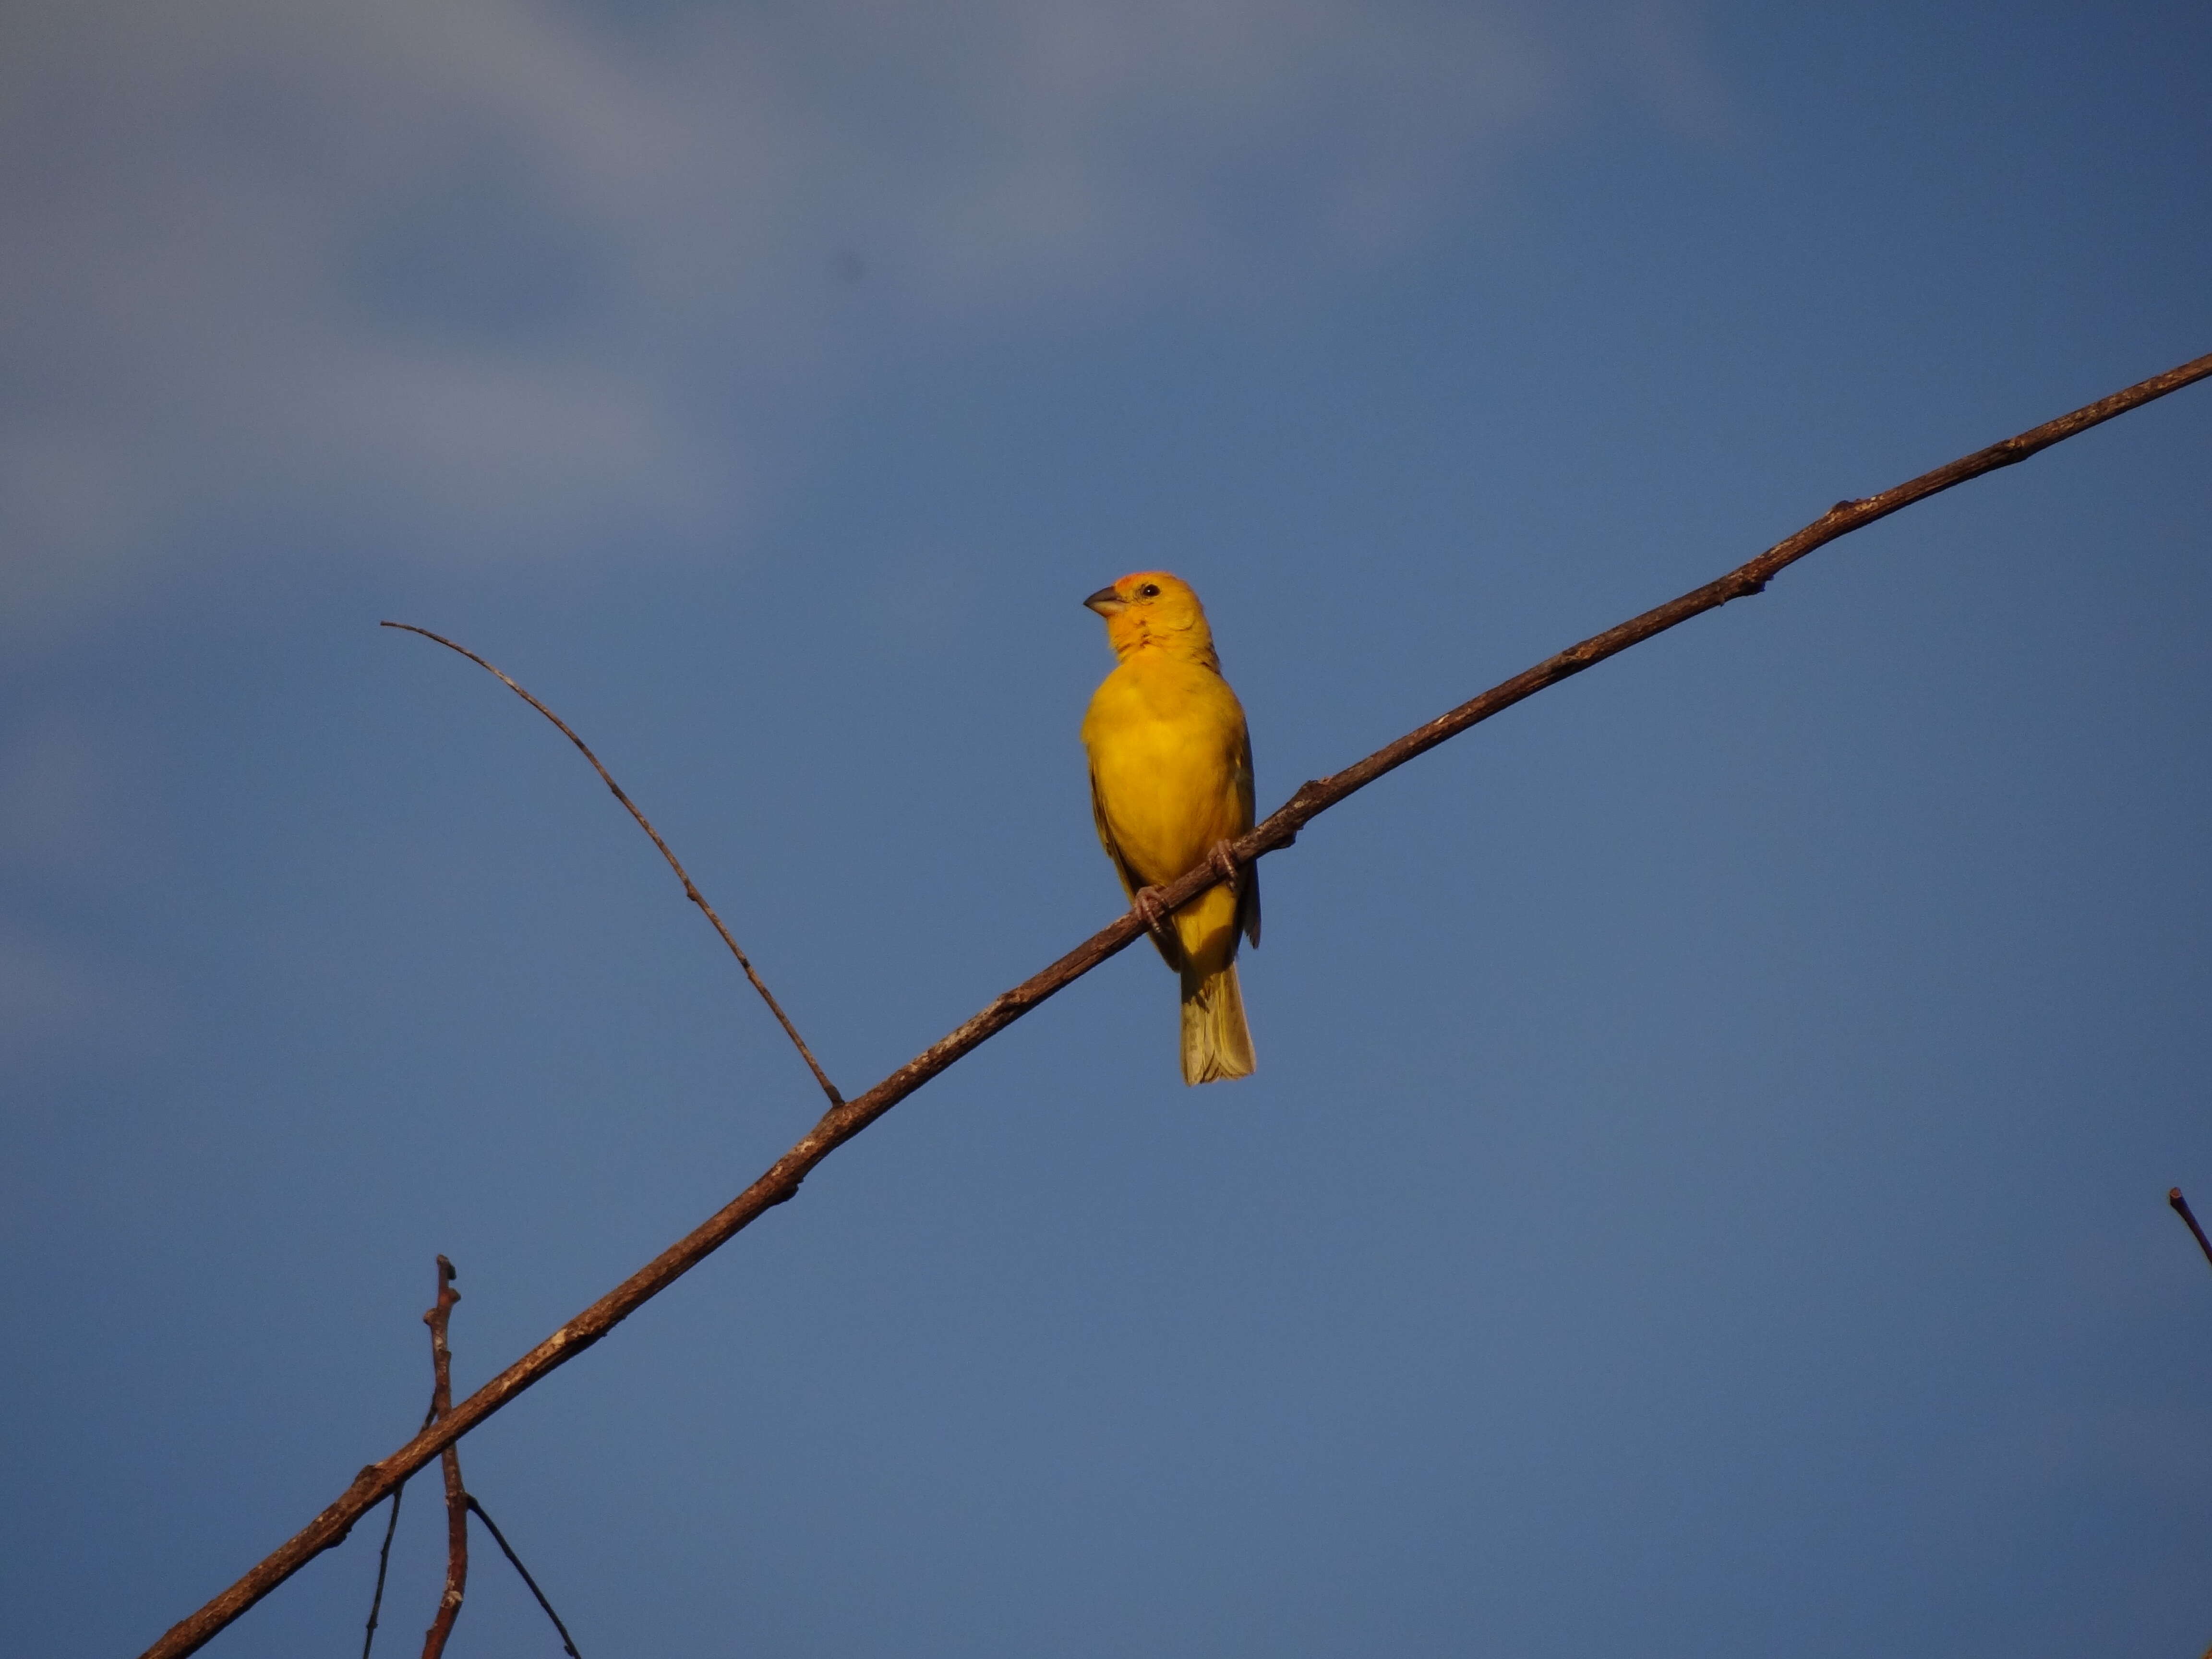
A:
0 0 1701 624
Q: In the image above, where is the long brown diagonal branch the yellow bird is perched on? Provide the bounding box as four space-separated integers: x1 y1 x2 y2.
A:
142 340 2212 1659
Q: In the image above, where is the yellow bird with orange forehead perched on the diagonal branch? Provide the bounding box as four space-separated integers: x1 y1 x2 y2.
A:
1084 571 1259 1084
